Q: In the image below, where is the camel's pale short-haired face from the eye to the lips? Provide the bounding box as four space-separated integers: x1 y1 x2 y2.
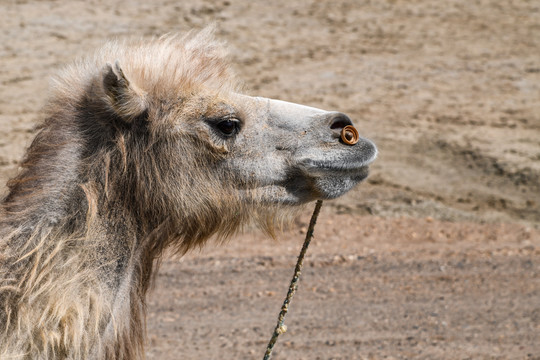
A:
199 94 377 205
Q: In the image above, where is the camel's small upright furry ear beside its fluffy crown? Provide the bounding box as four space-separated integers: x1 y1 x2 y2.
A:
103 61 147 121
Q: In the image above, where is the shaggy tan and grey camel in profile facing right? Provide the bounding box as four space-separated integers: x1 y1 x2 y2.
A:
0 30 377 359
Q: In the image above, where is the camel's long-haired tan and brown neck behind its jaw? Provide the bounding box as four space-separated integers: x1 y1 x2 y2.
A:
0 88 181 359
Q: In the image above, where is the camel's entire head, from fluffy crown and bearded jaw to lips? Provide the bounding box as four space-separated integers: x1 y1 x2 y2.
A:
47 31 377 245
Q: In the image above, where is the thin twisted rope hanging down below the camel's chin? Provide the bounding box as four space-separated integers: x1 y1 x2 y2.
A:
263 200 322 360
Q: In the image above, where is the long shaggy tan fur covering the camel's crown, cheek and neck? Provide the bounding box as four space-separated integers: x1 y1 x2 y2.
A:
0 31 292 359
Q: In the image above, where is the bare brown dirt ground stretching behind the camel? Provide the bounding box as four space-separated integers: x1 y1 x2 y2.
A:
0 0 540 360
